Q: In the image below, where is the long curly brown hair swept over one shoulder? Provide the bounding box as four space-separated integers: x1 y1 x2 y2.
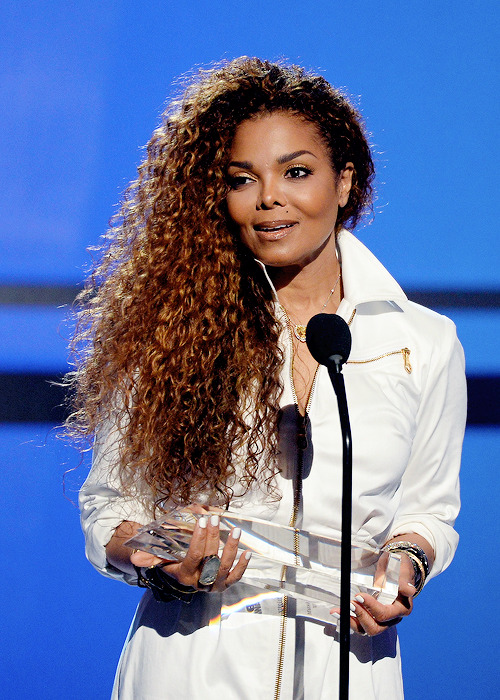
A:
66 57 373 511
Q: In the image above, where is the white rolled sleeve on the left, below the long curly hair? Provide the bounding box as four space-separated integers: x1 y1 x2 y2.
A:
79 416 152 585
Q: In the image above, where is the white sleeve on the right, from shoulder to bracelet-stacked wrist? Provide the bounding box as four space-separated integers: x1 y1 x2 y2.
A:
391 317 467 580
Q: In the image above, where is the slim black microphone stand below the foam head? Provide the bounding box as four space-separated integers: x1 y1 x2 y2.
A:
328 355 352 700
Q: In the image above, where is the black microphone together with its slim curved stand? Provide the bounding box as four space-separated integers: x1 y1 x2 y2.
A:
306 314 352 700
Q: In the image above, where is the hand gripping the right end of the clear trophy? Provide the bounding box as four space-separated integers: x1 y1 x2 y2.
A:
330 556 415 637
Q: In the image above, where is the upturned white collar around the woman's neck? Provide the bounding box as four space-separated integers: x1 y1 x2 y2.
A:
256 229 408 316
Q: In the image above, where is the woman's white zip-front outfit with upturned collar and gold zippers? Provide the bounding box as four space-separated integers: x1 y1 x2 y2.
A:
80 230 466 700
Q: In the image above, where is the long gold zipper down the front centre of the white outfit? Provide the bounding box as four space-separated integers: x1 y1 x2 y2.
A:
274 314 318 700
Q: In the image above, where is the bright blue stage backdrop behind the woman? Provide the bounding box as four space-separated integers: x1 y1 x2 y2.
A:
0 0 500 700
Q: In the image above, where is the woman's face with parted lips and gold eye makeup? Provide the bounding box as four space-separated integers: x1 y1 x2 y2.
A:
227 112 352 268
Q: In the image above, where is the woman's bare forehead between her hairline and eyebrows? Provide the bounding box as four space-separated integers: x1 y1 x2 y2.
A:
231 112 329 158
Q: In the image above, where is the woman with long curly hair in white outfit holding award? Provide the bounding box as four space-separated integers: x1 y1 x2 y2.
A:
71 58 465 700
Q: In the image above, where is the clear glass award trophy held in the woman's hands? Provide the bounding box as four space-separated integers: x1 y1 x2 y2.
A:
126 509 400 624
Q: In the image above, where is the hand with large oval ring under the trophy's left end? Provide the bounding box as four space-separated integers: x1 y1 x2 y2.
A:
130 514 250 591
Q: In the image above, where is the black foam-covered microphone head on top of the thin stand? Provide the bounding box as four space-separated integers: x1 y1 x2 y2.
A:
306 314 352 367
